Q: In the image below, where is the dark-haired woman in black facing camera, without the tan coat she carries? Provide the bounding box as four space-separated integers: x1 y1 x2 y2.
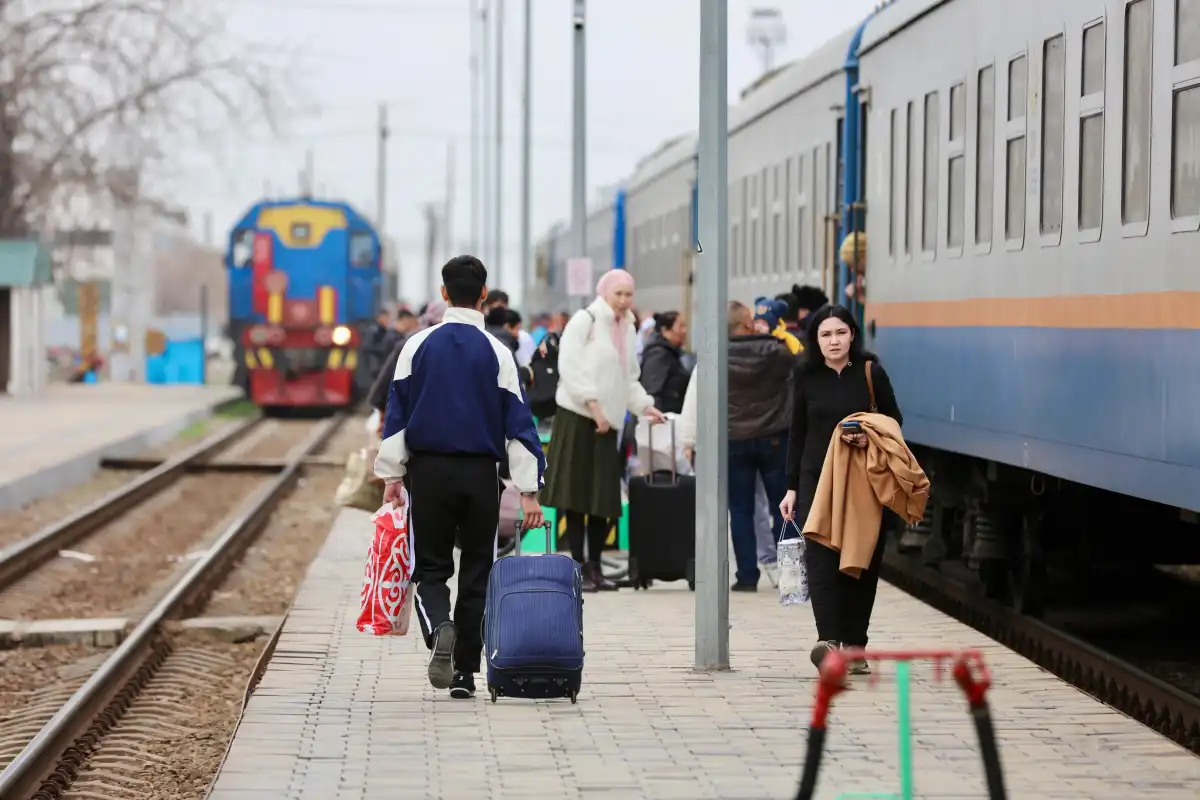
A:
779 306 904 675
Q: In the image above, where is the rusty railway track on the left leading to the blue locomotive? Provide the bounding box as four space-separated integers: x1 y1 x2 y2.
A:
0 416 344 800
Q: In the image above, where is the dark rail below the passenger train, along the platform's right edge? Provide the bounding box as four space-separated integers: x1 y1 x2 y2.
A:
882 553 1200 754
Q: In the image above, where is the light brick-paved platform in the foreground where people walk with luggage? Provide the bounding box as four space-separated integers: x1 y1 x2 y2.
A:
210 511 1200 800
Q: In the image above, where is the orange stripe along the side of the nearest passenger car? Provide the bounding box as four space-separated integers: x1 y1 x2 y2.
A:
866 291 1200 330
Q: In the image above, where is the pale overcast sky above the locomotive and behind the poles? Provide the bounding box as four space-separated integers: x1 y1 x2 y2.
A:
176 0 876 301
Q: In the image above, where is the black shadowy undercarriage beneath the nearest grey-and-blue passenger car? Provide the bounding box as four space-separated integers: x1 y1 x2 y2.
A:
889 446 1200 616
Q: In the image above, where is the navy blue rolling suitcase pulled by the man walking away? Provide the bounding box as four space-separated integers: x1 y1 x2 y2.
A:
484 522 583 703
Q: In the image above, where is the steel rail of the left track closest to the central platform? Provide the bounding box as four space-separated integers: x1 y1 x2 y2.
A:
0 415 343 800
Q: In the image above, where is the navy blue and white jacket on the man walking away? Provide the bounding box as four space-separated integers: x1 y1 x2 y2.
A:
374 307 546 492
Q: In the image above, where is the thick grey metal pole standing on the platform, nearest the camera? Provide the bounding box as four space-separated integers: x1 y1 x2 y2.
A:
695 0 730 672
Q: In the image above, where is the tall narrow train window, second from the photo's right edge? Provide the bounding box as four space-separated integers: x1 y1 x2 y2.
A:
1121 0 1154 224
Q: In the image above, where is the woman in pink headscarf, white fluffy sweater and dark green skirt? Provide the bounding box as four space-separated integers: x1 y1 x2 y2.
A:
541 270 664 591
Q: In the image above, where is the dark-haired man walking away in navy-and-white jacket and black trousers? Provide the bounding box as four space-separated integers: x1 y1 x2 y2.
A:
376 255 546 699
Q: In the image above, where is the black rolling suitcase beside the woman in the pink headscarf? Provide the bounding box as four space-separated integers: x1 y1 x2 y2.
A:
629 420 696 589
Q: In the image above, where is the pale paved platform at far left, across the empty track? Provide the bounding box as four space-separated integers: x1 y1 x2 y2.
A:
0 384 241 510
